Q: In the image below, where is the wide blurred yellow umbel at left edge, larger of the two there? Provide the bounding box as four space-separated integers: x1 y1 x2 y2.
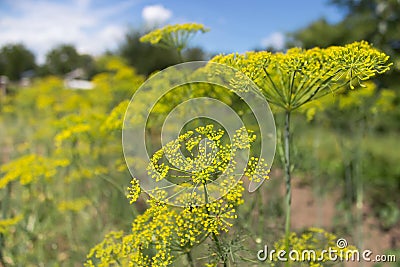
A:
0 154 69 189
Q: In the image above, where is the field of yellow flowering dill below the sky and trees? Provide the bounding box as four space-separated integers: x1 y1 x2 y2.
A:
0 17 400 266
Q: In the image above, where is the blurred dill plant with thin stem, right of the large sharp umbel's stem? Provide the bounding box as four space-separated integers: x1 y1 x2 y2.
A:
301 81 396 253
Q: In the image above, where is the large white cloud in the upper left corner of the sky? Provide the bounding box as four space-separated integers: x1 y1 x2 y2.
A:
0 0 134 63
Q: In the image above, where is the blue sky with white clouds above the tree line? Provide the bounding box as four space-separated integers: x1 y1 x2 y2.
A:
0 0 343 63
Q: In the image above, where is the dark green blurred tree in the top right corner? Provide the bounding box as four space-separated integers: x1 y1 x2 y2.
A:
289 0 400 88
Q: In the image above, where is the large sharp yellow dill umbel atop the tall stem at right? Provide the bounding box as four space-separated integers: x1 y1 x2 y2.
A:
211 41 392 111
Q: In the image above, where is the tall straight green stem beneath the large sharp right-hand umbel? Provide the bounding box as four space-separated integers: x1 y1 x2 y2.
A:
284 110 292 266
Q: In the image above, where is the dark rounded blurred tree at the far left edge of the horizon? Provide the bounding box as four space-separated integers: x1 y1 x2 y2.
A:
0 44 36 81
